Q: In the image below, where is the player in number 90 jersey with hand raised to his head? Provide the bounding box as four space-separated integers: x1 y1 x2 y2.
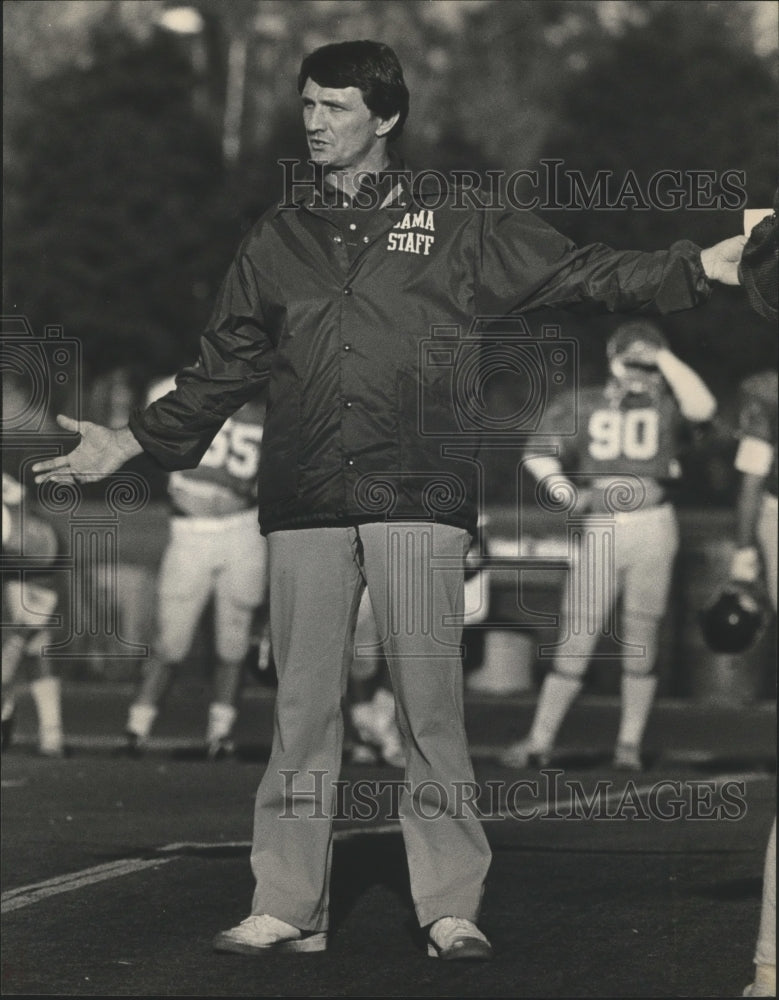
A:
500 320 716 771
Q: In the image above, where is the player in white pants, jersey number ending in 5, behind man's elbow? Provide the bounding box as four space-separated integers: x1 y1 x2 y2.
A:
122 379 267 759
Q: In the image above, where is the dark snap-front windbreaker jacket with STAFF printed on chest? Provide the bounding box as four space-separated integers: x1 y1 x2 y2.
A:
130 170 710 534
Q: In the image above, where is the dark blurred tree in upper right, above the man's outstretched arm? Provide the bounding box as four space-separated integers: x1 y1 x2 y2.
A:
543 0 777 249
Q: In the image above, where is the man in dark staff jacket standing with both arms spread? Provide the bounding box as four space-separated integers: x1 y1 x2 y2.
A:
37 42 744 959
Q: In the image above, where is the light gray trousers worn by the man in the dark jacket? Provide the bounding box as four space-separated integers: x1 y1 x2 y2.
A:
251 522 491 930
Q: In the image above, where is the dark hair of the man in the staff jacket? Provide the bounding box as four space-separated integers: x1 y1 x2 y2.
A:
298 41 408 139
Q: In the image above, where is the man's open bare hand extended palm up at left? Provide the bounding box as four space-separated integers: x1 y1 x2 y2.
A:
32 416 143 483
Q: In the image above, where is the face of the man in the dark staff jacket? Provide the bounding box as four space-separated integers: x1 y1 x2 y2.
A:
301 78 391 170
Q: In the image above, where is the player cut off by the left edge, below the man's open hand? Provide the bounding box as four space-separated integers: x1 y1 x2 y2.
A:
2 472 65 757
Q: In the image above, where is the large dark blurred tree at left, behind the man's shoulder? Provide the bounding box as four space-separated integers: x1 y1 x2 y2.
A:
4 19 238 382
